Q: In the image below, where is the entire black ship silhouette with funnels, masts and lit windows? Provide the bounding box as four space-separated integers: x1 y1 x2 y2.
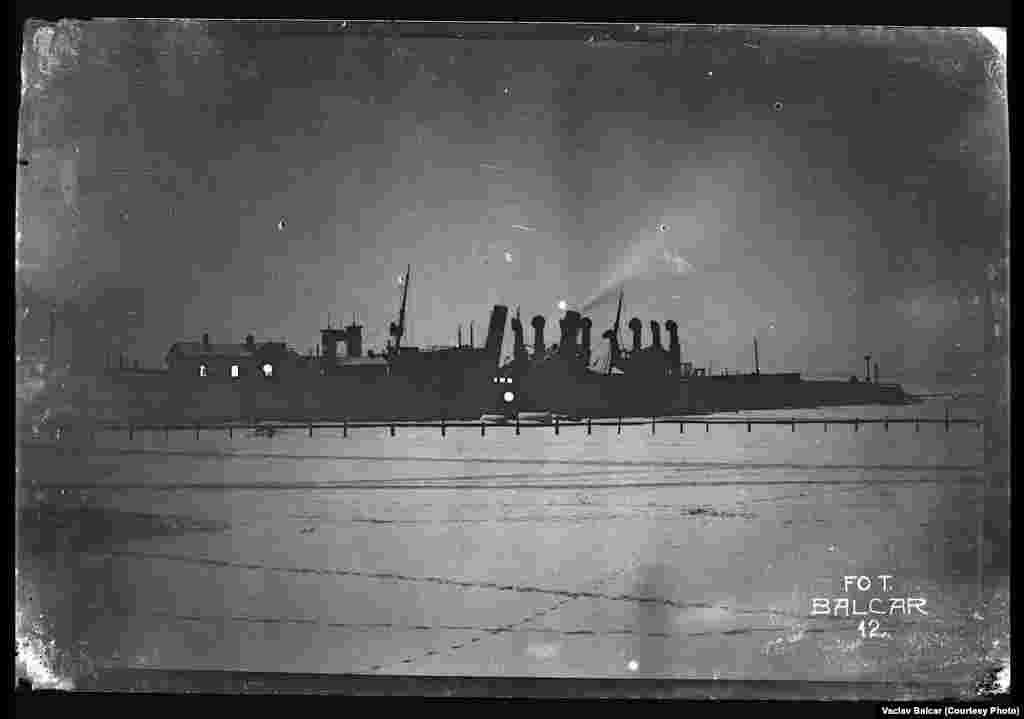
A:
64 268 912 423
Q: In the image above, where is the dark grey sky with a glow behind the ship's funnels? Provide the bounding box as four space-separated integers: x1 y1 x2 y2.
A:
17 20 1009 375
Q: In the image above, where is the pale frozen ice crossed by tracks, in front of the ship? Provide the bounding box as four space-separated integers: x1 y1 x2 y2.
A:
18 406 1009 692
